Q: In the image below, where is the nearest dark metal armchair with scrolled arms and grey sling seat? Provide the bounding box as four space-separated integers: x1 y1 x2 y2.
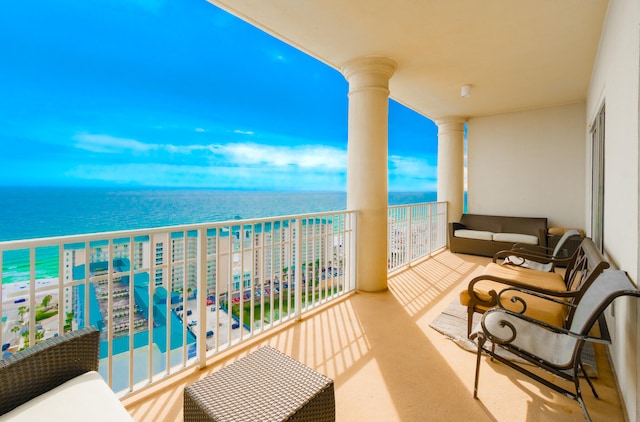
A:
471 270 640 421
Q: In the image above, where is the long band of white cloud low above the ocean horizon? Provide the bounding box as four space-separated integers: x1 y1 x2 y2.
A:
73 134 437 190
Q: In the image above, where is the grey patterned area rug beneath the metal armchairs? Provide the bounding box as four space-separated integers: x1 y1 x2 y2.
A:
429 299 598 378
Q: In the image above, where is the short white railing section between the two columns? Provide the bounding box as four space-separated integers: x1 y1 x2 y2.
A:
387 202 447 272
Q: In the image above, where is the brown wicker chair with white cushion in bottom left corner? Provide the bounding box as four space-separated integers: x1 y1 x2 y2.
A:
0 327 133 421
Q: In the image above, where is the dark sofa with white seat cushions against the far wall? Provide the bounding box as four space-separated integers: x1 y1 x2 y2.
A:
448 214 547 256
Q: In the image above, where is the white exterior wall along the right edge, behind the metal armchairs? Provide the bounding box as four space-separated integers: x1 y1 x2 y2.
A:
585 0 640 421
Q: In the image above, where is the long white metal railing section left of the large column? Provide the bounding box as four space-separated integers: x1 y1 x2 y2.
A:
0 212 356 395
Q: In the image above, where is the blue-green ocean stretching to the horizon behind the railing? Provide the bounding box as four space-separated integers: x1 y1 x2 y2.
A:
0 187 436 283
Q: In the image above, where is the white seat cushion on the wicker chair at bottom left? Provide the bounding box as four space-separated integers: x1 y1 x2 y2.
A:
0 371 133 422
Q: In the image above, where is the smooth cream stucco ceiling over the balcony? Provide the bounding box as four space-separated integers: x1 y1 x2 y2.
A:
209 0 607 119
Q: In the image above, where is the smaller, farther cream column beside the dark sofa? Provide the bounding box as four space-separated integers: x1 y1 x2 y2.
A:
435 116 466 221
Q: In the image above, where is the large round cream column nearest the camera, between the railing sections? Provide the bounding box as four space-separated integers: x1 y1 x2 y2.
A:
341 57 397 292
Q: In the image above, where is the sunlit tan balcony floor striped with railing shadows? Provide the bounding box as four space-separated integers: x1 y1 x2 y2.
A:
124 251 624 422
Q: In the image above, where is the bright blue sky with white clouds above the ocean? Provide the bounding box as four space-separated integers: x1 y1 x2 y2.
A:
0 0 437 191
